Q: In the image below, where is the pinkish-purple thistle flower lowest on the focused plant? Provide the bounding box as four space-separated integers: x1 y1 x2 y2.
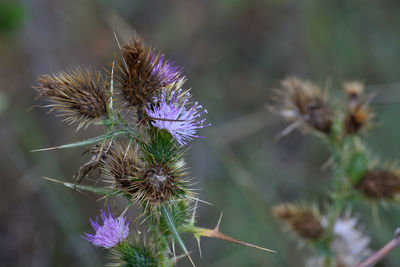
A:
82 210 129 248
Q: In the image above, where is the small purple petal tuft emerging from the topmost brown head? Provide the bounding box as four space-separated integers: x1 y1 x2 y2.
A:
151 55 183 86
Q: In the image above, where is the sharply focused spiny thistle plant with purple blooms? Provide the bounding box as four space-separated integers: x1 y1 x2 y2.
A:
35 37 271 266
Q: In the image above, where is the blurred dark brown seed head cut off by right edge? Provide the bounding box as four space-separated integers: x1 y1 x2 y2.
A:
356 169 400 200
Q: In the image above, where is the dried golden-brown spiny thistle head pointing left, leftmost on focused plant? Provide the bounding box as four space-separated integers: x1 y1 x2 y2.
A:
35 68 110 129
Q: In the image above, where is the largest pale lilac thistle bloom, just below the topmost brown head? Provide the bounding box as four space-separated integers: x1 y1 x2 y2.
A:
146 90 210 145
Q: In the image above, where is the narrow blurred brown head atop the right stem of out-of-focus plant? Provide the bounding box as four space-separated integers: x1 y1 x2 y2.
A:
343 81 374 134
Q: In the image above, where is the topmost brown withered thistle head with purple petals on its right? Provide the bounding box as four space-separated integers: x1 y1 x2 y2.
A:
116 38 183 112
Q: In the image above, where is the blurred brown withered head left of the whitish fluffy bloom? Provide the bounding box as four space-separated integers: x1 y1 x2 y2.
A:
273 203 323 240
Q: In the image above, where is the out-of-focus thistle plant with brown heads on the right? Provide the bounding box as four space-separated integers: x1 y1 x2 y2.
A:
271 77 400 266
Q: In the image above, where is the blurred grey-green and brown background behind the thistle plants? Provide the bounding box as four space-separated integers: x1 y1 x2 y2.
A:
0 0 400 267
